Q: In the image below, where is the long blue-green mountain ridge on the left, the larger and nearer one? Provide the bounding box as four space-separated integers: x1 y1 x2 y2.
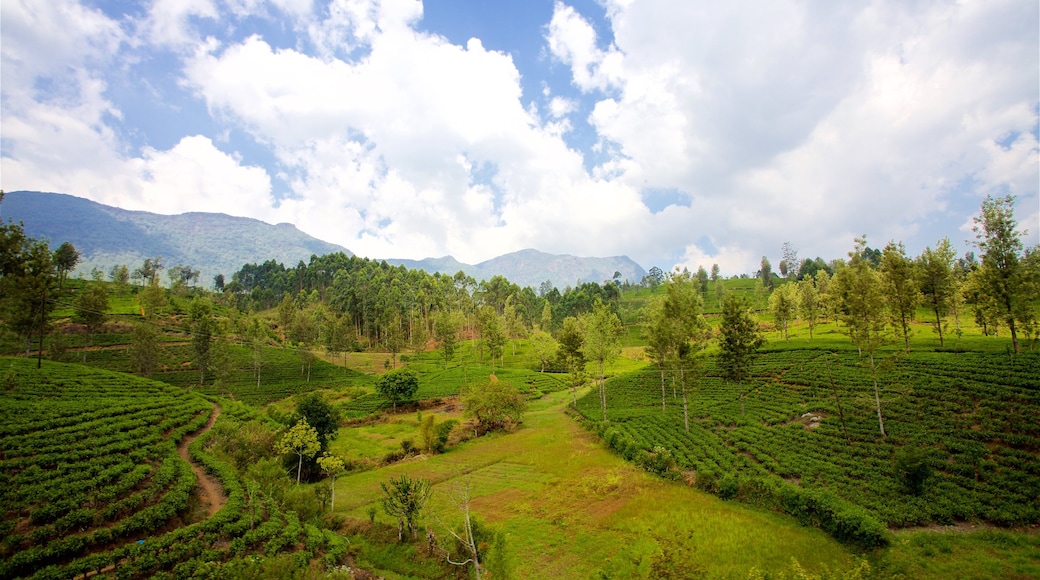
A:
0 191 350 286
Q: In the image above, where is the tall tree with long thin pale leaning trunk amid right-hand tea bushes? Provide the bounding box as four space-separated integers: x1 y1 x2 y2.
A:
831 236 886 437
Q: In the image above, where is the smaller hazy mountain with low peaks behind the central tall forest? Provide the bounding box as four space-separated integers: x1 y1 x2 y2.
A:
387 249 647 290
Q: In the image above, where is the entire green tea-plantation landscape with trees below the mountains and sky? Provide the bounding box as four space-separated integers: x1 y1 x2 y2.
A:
0 195 1040 578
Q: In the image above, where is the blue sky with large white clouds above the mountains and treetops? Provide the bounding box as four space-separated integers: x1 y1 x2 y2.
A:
0 0 1040 275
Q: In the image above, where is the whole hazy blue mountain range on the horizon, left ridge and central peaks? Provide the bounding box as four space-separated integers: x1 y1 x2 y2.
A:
0 191 646 290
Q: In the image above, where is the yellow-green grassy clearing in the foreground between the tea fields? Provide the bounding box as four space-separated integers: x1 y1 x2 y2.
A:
336 392 857 578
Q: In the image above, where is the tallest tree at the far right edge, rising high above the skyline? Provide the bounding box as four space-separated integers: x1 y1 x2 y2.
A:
972 194 1035 353
